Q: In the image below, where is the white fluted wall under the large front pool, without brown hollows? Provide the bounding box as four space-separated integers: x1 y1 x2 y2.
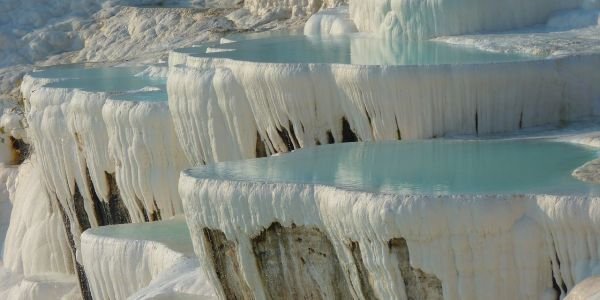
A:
179 173 600 299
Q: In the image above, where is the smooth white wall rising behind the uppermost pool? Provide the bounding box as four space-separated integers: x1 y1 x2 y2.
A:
350 0 583 39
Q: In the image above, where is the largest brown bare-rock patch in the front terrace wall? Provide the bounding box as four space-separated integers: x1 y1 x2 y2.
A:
252 222 352 299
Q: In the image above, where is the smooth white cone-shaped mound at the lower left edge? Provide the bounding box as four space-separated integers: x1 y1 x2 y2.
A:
0 157 81 299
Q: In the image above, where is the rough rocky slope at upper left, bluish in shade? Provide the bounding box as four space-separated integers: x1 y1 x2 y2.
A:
0 0 235 101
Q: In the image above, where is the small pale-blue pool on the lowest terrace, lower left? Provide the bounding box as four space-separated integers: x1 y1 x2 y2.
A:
88 217 194 254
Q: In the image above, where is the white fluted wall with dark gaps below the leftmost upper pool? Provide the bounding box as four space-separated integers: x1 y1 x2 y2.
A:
20 69 187 295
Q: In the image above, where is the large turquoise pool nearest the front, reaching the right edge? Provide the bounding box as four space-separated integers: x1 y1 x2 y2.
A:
189 140 600 195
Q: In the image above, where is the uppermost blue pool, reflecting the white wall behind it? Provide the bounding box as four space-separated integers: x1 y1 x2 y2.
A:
186 32 535 65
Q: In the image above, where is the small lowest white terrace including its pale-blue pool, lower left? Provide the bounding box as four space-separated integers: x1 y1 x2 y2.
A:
81 219 215 299
